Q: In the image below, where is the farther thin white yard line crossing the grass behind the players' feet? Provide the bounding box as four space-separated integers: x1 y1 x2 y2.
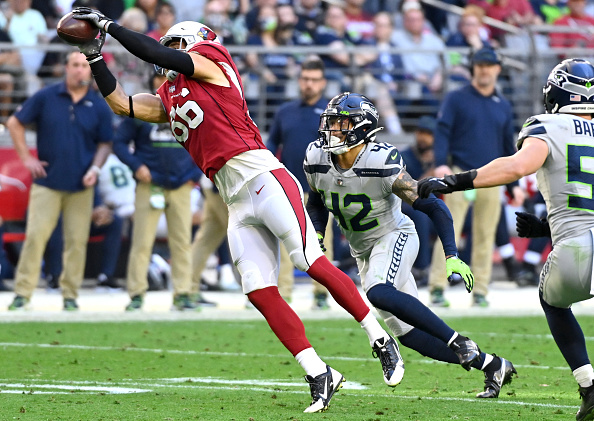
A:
0 342 569 370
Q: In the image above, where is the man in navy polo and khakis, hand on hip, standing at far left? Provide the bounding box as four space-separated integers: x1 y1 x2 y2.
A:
6 51 113 310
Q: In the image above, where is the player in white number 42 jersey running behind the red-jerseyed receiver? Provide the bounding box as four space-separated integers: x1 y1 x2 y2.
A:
304 92 515 398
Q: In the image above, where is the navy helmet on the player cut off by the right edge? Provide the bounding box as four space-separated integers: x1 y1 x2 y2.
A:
543 58 594 114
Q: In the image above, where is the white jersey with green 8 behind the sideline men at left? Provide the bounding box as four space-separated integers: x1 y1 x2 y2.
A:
98 154 136 218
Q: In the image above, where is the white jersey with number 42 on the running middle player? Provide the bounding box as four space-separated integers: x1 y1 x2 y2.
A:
303 140 415 257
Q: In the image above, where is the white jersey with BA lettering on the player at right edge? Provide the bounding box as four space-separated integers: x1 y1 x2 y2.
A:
518 114 594 244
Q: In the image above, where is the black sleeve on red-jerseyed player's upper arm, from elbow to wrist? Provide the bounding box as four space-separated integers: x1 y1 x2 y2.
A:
108 22 194 76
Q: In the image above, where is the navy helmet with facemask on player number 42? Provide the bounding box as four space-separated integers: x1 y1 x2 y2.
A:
319 92 383 155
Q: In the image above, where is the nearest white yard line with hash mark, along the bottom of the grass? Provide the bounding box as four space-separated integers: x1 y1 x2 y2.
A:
0 377 578 410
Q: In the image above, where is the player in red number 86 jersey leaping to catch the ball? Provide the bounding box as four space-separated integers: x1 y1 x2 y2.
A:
73 8 404 412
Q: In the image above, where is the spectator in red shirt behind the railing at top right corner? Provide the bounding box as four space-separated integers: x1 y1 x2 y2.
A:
550 0 594 48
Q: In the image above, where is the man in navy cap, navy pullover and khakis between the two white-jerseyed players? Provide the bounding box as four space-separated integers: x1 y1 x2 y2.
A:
429 47 524 307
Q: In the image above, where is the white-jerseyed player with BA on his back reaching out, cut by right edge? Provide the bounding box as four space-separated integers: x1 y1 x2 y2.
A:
418 59 594 421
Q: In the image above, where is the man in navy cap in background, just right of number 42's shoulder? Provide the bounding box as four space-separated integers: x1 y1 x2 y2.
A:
402 116 437 287
